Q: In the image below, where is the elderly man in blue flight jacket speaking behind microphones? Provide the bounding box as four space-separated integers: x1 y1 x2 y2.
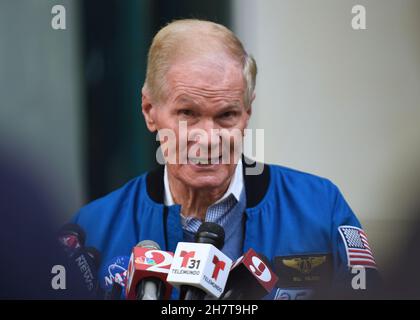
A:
74 20 376 299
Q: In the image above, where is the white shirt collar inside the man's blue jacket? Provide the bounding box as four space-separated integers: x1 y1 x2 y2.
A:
163 159 244 206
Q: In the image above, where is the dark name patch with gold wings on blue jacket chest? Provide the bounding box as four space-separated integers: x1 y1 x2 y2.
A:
274 254 333 287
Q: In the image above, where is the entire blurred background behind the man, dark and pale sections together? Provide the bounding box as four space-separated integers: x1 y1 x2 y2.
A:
0 0 420 288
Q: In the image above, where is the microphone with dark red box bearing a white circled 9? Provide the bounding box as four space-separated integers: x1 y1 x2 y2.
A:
222 249 278 300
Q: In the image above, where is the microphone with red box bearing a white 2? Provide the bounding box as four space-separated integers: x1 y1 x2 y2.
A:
126 240 173 300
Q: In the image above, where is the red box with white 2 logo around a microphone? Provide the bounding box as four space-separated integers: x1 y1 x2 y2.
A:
126 247 173 300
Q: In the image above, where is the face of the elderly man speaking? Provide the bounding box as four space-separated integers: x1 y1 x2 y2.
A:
145 55 251 189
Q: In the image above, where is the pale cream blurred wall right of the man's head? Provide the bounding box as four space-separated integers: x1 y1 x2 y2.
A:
232 0 420 278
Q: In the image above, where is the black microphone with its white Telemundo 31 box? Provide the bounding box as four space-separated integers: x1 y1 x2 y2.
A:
167 222 232 300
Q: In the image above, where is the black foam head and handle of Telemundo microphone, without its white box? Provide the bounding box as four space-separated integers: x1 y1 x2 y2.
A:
180 222 225 300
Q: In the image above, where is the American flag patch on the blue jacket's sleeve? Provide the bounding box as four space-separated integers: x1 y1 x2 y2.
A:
338 226 377 269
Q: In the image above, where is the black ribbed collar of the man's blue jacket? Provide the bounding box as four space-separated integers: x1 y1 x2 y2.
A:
146 156 270 209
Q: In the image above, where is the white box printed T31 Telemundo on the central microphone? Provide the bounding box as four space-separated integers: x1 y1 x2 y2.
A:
167 242 232 298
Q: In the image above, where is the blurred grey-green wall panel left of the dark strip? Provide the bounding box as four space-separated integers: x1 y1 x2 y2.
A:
0 0 87 222
